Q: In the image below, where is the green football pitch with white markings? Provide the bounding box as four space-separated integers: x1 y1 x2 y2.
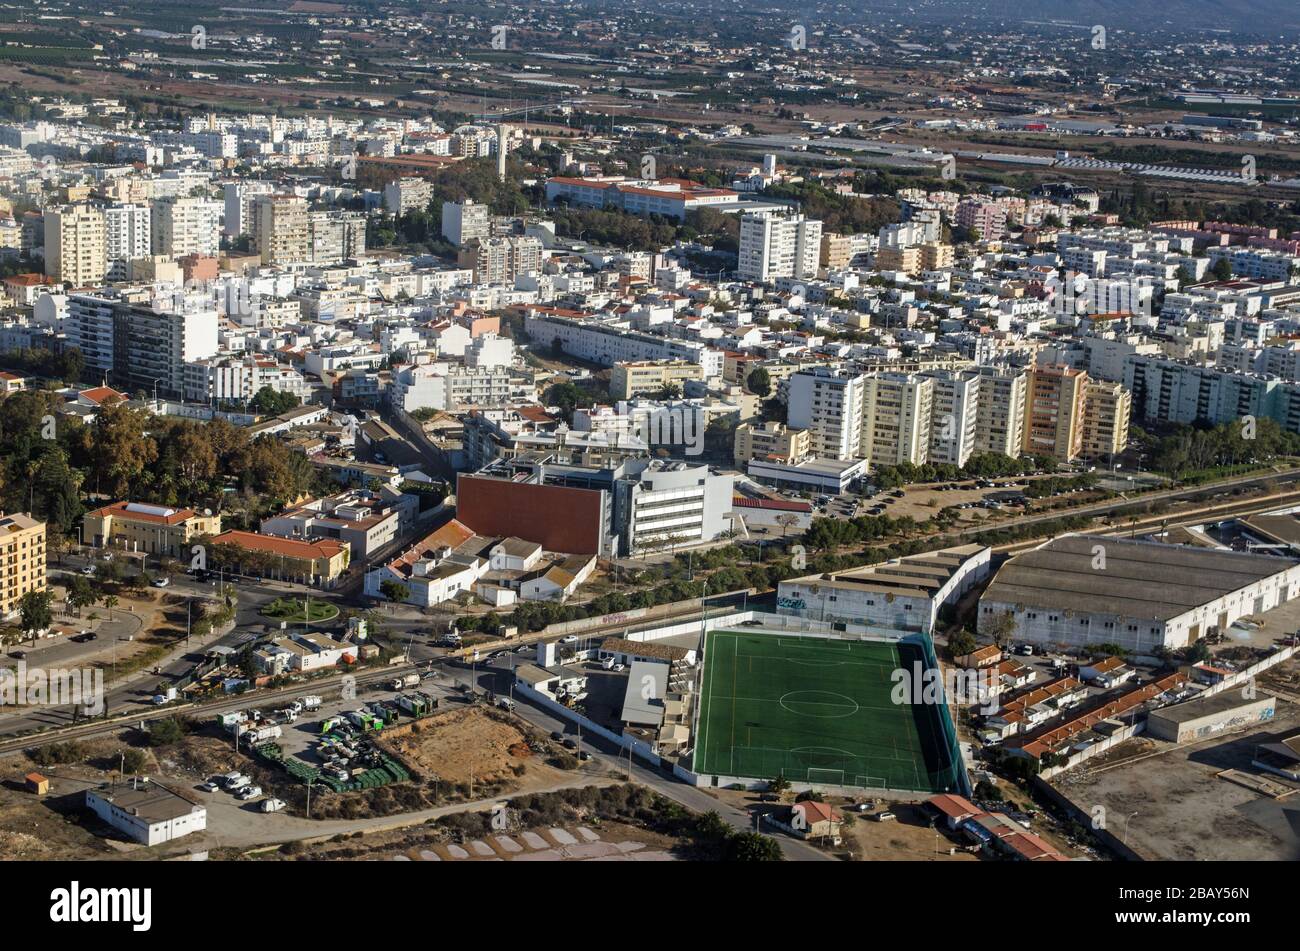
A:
694 631 956 793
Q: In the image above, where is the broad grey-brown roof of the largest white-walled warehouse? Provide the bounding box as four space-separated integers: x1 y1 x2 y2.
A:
980 534 1300 621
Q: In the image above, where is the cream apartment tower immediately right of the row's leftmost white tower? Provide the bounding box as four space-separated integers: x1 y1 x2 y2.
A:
862 373 935 466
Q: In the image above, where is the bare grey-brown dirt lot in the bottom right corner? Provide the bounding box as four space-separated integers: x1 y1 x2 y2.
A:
1053 699 1300 861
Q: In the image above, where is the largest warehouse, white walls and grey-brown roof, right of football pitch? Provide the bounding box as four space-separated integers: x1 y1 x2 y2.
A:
979 534 1300 652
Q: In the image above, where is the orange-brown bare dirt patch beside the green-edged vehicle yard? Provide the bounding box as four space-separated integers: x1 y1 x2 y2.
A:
382 707 562 791
